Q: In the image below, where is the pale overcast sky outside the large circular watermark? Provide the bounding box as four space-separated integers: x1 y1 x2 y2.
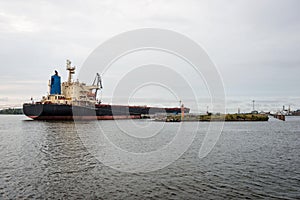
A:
0 0 300 109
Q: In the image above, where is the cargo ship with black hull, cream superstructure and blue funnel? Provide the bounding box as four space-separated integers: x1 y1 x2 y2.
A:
23 60 190 120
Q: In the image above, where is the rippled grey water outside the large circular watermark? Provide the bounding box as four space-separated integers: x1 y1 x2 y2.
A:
0 115 300 199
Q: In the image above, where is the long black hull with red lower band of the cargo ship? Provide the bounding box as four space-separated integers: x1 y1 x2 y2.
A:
23 103 190 120
